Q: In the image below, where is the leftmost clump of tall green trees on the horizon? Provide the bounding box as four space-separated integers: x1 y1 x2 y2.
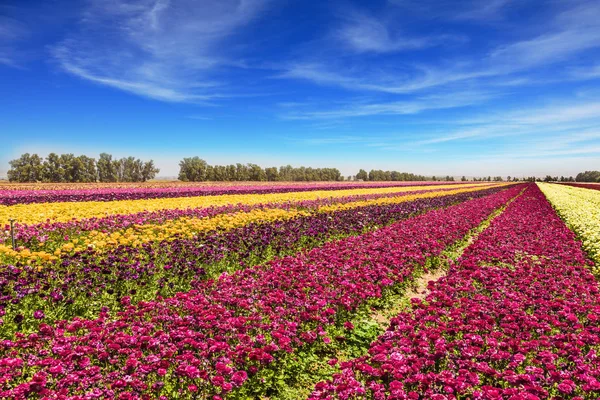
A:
7 153 160 182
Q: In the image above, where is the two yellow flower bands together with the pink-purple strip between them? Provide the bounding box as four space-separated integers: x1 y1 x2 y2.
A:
0 185 500 261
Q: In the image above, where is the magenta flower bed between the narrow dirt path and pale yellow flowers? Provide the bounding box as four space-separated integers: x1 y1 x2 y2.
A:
310 184 600 400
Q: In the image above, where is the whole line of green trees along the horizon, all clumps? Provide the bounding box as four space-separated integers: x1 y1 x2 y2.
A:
7 153 600 182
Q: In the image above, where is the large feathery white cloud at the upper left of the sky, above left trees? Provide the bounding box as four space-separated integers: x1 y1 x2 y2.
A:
51 0 266 102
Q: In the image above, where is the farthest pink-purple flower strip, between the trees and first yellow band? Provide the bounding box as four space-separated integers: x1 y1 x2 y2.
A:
0 182 462 205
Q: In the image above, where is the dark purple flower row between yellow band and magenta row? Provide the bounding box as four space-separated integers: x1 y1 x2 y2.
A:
0 187 510 336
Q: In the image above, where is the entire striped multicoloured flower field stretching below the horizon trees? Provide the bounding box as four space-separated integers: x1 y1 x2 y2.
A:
0 182 600 400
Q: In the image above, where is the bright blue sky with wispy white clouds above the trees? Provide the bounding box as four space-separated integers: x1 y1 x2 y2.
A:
0 0 600 176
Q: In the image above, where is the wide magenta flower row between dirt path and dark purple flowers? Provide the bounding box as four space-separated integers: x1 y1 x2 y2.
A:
0 187 520 399
